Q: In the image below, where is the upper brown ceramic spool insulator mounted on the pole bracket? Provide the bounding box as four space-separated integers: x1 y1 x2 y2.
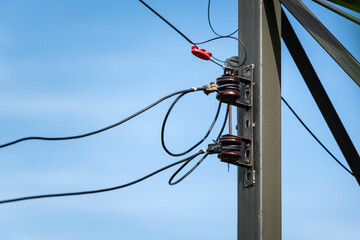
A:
216 74 241 105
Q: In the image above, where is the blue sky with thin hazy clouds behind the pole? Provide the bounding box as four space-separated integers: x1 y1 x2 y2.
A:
0 0 360 240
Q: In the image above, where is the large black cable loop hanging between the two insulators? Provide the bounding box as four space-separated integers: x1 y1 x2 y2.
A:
161 93 221 157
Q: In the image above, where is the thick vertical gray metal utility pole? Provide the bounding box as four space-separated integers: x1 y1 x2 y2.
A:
238 0 281 240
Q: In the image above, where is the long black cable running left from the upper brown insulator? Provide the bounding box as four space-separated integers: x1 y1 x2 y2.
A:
0 87 206 148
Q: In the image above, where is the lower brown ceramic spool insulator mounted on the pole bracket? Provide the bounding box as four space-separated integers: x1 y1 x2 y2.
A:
218 134 242 164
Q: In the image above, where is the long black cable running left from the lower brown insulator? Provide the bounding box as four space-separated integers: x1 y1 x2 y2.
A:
0 149 206 204
